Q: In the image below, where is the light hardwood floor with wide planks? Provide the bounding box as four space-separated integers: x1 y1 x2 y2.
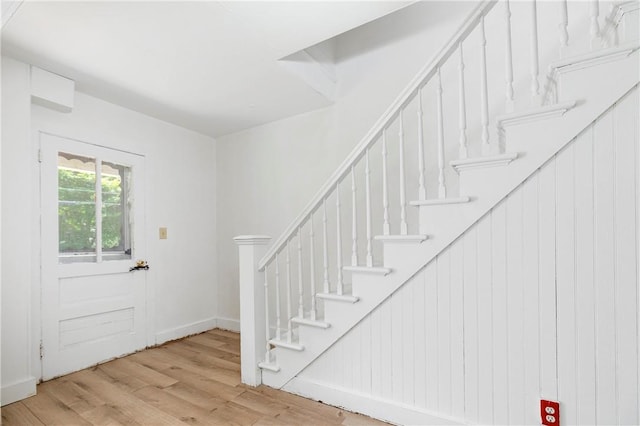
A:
2 329 384 426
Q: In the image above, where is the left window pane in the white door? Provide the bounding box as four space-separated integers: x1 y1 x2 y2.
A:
58 152 96 262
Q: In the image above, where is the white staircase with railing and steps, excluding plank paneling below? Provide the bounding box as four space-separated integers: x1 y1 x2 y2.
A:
236 2 640 396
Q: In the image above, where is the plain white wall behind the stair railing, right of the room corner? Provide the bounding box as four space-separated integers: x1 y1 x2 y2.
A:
217 2 474 320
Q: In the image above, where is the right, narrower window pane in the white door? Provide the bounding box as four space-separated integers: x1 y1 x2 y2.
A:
101 162 131 260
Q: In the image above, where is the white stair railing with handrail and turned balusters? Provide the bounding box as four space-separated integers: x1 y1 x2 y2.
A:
236 0 599 382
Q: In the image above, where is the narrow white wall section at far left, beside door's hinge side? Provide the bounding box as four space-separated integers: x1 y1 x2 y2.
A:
1 57 35 402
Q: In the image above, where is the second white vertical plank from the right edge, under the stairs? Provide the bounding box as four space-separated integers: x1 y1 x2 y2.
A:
594 104 617 424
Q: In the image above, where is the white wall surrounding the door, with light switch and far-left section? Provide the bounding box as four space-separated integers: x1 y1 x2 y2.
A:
2 58 217 403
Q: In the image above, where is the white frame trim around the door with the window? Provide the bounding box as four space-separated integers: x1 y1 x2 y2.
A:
35 129 156 383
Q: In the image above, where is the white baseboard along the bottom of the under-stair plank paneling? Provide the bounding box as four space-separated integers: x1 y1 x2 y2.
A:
283 377 465 425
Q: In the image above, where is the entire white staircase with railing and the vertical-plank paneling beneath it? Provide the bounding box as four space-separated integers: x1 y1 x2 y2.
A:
240 1 640 424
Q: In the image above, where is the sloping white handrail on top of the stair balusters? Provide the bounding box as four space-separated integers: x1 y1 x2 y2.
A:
258 0 498 271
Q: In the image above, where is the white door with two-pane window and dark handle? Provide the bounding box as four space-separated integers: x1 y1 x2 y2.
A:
40 133 147 380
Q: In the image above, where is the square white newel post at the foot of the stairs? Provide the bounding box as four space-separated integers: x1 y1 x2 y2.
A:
234 235 271 386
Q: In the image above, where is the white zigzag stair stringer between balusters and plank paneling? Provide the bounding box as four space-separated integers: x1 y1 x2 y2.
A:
262 45 640 388
